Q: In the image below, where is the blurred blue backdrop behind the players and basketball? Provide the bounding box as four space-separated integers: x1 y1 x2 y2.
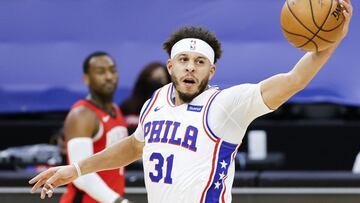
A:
0 0 360 113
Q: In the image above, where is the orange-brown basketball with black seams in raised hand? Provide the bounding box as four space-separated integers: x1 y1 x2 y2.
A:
280 0 345 51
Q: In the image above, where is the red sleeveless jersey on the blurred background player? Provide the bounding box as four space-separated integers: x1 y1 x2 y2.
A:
60 100 128 203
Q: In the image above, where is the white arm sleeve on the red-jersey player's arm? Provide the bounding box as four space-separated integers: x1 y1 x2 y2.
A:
67 137 119 203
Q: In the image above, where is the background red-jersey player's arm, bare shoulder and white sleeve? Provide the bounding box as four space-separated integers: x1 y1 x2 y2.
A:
64 106 129 203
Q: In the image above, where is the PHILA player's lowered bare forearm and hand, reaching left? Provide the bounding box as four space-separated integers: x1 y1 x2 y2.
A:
29 135 144 199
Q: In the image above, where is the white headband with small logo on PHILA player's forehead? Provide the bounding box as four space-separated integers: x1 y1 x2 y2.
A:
170 38 215 64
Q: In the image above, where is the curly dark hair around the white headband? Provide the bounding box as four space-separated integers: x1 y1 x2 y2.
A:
163 26 222 63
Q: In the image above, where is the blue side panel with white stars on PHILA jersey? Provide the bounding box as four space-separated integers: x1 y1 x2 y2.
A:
205 141 237 203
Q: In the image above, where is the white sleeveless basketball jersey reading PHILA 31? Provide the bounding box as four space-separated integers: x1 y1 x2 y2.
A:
140 84 238 203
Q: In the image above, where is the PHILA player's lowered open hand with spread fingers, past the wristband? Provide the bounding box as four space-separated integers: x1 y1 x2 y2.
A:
29 165 78 199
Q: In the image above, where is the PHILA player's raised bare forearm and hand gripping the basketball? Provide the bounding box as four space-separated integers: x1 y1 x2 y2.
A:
261 0 353 109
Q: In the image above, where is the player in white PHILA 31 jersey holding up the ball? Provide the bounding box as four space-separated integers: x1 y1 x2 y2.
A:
29 0 352 203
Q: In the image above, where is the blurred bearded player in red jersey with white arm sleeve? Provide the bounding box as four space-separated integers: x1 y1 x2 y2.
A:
60 52 133 203
